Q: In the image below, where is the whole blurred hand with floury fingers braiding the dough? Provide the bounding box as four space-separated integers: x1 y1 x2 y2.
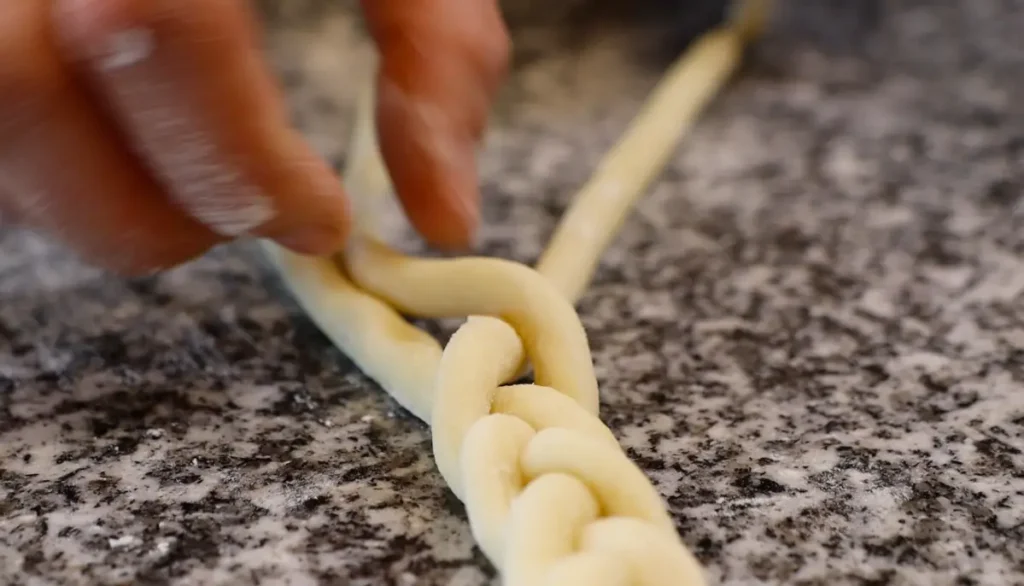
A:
0 0 509 275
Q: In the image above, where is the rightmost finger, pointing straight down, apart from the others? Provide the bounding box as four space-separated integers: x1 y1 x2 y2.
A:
362 0 509 249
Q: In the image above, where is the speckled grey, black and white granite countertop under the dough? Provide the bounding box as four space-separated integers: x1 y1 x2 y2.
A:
0 0 1024 586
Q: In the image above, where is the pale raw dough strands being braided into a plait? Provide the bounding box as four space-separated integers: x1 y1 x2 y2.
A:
263 0 766 586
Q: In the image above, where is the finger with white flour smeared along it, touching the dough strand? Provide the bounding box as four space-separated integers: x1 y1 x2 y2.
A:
58 0 348 254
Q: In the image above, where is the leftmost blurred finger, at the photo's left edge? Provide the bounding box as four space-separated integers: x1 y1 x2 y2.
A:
0 1 218 274
